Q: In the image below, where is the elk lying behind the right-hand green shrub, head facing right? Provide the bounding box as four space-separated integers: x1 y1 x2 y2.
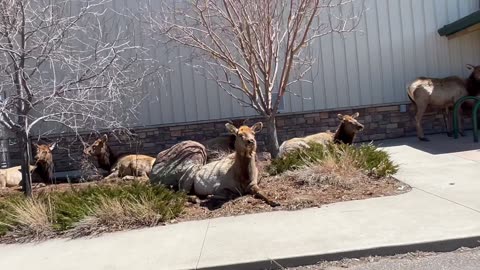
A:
279 112 364 158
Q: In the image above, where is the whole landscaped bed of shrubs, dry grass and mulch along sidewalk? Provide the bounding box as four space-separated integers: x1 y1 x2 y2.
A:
0 144 410 243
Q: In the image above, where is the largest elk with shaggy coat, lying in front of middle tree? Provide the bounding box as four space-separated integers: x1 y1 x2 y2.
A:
150 122 279 207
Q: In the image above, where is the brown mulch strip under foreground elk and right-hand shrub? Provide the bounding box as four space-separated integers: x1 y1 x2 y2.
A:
177 173 411 221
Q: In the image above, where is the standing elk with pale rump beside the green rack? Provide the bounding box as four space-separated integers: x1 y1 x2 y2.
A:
407 65 480 141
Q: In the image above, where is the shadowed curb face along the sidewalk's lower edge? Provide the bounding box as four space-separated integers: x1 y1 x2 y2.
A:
196 236 480 270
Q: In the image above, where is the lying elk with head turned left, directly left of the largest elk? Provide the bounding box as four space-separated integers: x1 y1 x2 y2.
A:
83 134 155 180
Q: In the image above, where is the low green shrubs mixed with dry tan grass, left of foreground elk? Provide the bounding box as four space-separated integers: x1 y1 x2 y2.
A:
0 183 186 238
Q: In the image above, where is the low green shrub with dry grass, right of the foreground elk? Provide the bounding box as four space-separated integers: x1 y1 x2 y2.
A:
268 143 398 177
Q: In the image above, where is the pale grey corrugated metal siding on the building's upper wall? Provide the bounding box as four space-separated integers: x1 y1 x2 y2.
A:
131 0 480 125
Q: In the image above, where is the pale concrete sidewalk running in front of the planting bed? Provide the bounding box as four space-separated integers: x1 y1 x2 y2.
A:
0 135 480 270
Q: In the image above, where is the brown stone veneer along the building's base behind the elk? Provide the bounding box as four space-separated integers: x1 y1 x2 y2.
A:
5 105 471 172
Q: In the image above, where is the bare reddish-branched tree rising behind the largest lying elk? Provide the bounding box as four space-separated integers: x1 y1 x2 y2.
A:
145 0 364 157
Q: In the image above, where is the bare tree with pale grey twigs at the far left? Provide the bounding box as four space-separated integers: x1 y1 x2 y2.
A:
0 0 153 195
